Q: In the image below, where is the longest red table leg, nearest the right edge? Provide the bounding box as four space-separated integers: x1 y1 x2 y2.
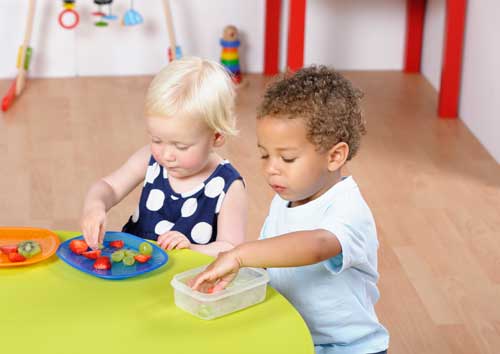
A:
438 0 467 118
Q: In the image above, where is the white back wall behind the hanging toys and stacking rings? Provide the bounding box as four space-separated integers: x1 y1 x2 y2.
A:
0 0 406 78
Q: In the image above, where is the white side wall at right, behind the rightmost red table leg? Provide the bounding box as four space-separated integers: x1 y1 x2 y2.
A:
422 0 500 163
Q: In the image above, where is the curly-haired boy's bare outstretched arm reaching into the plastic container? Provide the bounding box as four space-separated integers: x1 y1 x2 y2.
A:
190 229 342 291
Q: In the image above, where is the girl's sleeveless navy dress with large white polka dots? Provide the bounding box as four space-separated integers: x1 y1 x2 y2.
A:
123 156 243 244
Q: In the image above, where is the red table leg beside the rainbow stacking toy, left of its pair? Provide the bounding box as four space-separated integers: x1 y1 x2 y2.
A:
264 0 281 75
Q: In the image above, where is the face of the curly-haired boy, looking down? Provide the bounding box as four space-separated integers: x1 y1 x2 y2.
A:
257 116 338 206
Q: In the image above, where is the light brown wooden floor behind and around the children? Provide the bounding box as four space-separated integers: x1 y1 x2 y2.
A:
0 72 500 354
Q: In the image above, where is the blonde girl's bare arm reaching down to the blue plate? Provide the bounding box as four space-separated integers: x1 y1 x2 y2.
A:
81 145 151 248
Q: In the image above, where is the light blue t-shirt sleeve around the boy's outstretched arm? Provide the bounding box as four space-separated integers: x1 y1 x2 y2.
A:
319 207 371 274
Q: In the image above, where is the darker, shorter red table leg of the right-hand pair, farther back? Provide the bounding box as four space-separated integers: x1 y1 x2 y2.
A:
404 0 427 73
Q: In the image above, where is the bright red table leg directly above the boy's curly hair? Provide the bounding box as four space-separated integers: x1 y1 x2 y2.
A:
287 0 306 71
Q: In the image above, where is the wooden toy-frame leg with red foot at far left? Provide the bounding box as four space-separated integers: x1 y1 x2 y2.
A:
2 0 36 112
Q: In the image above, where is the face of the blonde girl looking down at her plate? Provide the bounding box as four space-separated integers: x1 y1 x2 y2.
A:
147 115 220 178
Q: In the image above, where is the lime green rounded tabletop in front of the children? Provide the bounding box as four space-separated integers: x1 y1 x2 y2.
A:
0 231 314 354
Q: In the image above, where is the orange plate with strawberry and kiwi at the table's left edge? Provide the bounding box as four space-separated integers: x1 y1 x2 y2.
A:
0 227 61 267
